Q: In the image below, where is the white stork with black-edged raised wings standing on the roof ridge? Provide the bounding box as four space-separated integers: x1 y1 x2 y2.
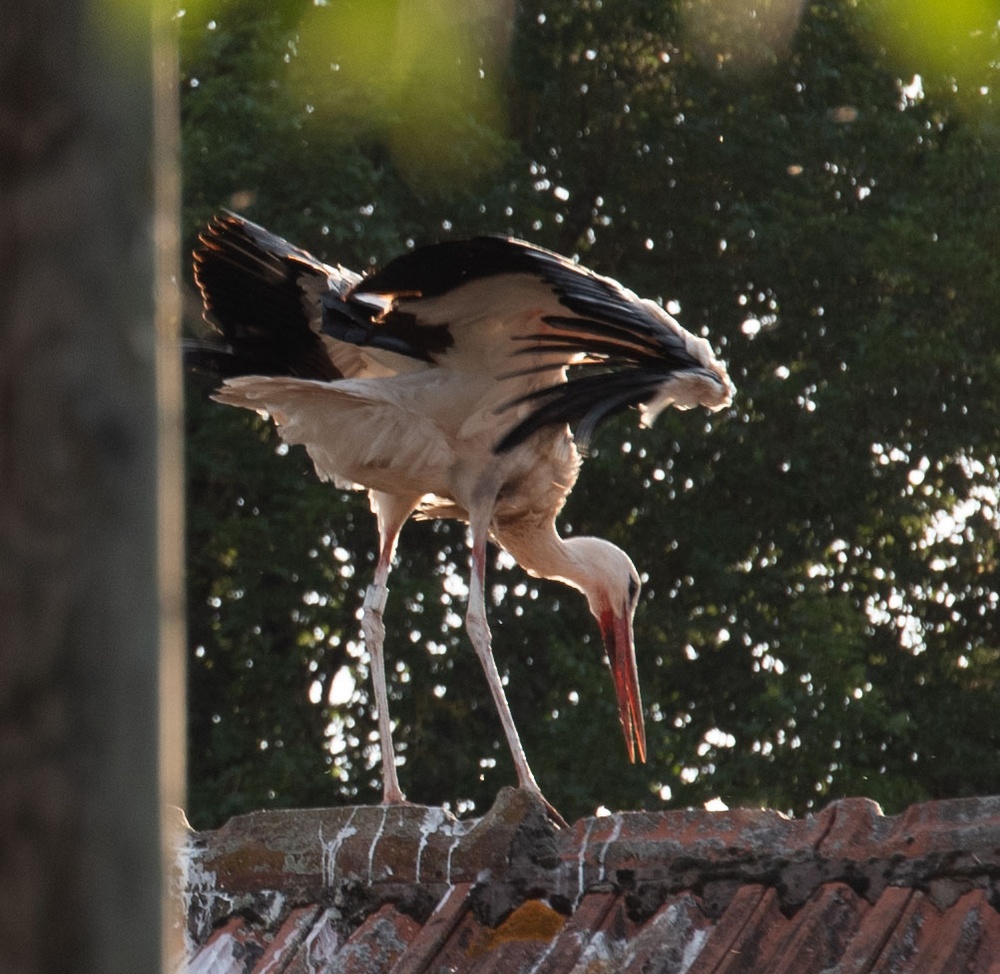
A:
188 213 734 819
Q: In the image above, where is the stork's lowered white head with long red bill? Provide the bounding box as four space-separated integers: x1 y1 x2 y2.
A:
566 538 646 762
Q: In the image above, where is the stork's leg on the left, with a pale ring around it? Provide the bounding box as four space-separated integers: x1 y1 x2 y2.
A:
361 491 419 805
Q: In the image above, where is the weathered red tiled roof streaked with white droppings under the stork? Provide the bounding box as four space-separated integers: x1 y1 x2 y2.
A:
180 789 1000 974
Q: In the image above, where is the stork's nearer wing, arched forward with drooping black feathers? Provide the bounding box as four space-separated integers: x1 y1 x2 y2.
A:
346 237 733 452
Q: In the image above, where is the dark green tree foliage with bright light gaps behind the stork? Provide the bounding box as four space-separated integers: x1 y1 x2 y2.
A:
182 0 1000 825
